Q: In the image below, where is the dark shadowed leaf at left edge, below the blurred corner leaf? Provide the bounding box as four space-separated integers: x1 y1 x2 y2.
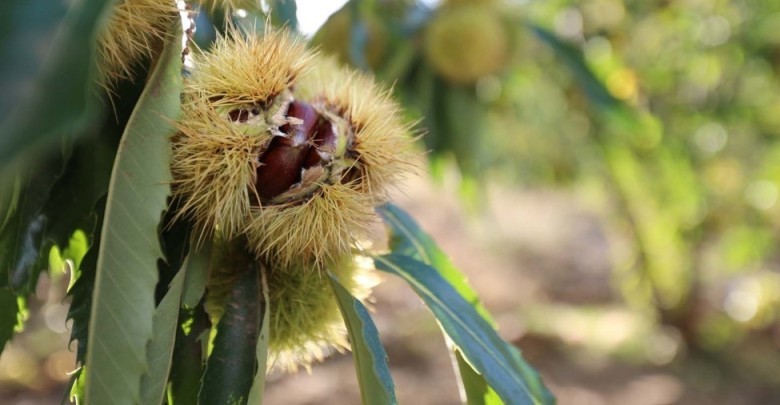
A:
0 131 116 294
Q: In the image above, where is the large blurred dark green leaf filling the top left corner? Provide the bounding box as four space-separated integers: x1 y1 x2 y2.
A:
0 0 113 167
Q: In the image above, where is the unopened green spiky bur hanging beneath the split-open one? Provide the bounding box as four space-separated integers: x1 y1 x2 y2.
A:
267 256 376 371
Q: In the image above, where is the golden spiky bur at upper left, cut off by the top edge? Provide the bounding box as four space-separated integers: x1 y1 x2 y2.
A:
97 0 178 89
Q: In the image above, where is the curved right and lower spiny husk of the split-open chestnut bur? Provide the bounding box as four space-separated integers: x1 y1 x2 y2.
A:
247 58 414 268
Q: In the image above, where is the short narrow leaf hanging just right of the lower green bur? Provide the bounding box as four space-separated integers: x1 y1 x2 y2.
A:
329 274 398 404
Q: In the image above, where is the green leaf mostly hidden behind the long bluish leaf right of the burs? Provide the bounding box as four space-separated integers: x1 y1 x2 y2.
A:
378 204 498 404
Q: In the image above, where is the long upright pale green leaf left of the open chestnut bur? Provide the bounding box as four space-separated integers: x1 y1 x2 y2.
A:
86 22 182 404
